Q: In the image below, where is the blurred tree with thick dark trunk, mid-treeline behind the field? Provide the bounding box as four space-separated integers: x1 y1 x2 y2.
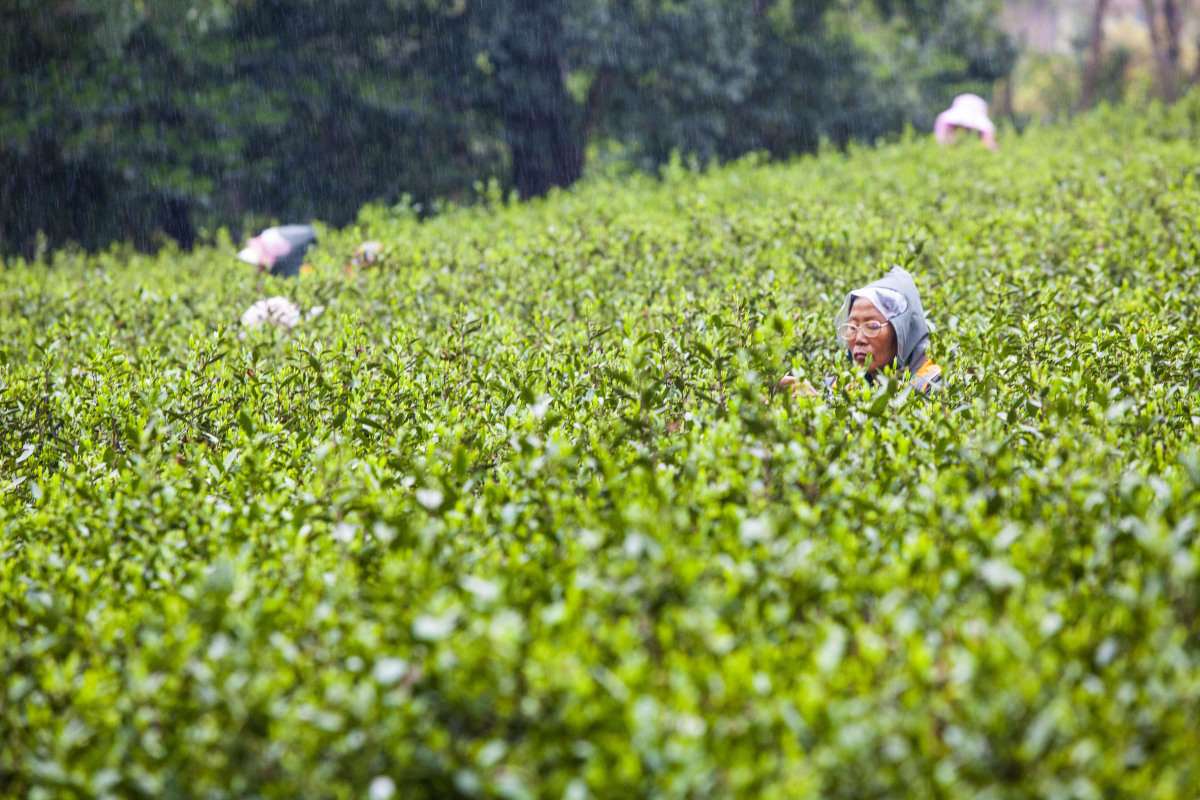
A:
470 0 754 197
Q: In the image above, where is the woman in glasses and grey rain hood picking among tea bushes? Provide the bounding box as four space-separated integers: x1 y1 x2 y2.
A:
779 266 942 395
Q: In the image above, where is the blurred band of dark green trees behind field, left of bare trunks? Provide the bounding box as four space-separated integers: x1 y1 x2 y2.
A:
0 0 1014 258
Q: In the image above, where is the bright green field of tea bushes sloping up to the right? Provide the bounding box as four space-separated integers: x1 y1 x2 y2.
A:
0 98 1200 800
